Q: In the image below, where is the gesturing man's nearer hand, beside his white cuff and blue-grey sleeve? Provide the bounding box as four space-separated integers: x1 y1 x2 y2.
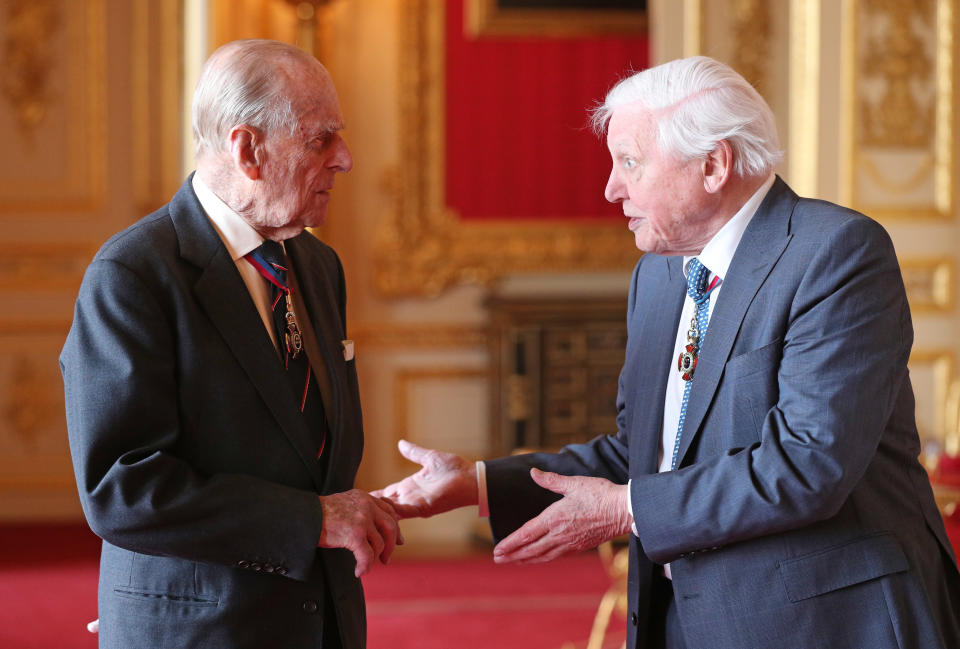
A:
493 469 633 564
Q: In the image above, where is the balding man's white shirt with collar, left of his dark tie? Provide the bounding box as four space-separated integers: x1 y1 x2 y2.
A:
193 174 283 349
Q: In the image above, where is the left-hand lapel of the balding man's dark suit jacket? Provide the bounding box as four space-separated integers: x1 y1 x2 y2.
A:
170 176 322 490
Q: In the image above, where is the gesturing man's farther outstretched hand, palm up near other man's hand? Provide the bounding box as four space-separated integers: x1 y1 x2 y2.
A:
372 440 479 518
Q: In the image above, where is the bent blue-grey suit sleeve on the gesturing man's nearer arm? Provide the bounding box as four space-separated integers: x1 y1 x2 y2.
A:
631 218 912 563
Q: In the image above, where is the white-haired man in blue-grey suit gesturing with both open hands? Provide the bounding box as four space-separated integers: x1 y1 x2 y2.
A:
382 57 960 649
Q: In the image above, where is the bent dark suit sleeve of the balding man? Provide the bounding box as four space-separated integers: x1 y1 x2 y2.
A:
61 257 322 579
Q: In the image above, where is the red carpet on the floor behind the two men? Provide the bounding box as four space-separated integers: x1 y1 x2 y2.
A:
0 525 625 649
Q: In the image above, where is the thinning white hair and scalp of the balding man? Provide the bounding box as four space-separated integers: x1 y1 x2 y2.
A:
193 39 316 155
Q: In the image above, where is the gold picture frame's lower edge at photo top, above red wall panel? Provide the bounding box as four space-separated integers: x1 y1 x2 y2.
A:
464 0 647 36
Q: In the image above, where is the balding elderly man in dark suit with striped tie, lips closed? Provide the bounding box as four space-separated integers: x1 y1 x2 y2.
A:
60 41 399 649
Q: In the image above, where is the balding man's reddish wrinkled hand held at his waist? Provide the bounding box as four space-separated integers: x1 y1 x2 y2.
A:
317 489 403 577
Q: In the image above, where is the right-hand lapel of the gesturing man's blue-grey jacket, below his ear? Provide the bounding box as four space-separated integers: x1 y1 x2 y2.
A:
677 178 798 467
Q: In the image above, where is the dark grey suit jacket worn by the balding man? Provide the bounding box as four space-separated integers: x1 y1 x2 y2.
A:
60 179 365 649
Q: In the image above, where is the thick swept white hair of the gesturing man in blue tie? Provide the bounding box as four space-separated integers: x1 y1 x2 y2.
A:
591 56 783 177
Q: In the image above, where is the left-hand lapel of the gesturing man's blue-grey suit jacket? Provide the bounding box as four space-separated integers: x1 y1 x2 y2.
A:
625 255 686 474
